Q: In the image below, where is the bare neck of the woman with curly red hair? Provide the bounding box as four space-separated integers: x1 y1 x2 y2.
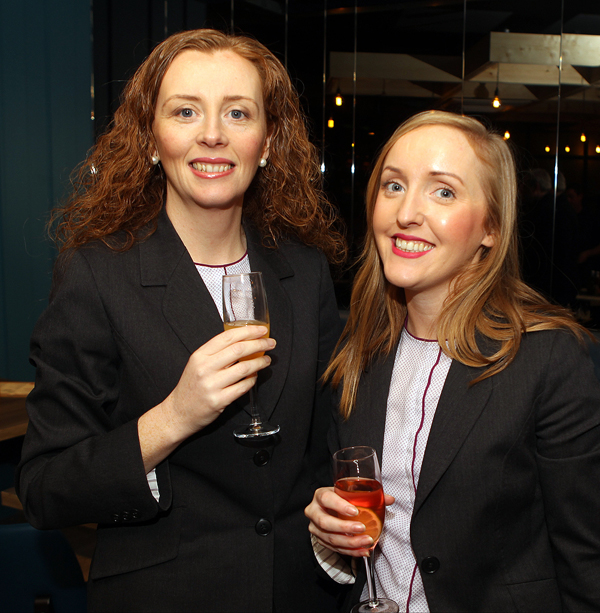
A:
166 200 246 266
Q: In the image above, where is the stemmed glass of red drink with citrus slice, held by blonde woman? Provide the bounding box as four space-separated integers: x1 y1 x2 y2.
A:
333 447 398 613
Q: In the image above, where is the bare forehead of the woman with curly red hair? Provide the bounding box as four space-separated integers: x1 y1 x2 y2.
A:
159 49 262 99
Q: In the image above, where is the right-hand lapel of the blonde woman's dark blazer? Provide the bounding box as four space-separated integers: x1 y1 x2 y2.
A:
414 361 493 513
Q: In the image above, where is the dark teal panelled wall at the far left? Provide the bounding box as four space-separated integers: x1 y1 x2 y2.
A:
0 0 93 380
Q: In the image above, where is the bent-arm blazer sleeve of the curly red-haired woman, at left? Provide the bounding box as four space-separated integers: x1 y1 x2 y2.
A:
16 252 164 528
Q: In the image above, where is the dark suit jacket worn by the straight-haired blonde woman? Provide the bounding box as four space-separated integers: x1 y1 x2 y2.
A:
330 331 600 612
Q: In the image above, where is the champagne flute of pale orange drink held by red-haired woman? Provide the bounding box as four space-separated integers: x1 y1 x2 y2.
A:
223 272 279 438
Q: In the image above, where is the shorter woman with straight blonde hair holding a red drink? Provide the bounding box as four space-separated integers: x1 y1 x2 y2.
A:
306 111 600 612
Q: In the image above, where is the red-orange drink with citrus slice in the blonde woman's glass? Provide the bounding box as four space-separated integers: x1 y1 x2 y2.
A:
335 477 385 547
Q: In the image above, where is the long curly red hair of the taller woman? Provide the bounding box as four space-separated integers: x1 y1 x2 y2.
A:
52 29 346 263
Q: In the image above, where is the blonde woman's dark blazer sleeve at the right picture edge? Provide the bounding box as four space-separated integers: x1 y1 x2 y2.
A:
535 332 600 611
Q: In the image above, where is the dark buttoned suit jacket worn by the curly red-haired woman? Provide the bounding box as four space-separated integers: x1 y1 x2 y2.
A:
17 208 339 612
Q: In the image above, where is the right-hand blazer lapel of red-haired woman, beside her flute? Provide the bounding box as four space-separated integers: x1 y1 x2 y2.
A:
244 225 294 419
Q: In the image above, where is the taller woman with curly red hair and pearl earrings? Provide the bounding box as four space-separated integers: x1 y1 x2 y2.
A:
18 30 345 612
